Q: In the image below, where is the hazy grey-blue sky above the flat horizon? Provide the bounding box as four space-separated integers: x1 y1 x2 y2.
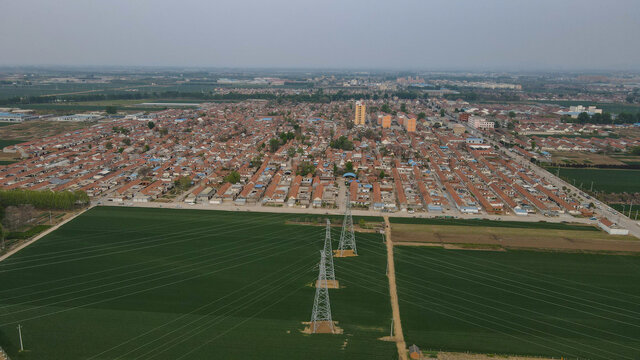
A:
0 0 640 70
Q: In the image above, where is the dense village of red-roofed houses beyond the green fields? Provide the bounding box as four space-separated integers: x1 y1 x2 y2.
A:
0 97 604 215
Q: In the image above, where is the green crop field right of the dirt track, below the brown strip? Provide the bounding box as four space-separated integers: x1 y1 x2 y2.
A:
395 246 640 359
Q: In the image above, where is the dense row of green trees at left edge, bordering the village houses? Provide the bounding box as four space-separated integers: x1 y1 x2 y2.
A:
0 189 89 210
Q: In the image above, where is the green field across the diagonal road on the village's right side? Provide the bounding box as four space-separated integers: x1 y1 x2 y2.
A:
548 167 640 193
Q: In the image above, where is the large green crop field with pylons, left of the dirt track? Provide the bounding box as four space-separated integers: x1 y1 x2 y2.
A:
0 207 397 360
